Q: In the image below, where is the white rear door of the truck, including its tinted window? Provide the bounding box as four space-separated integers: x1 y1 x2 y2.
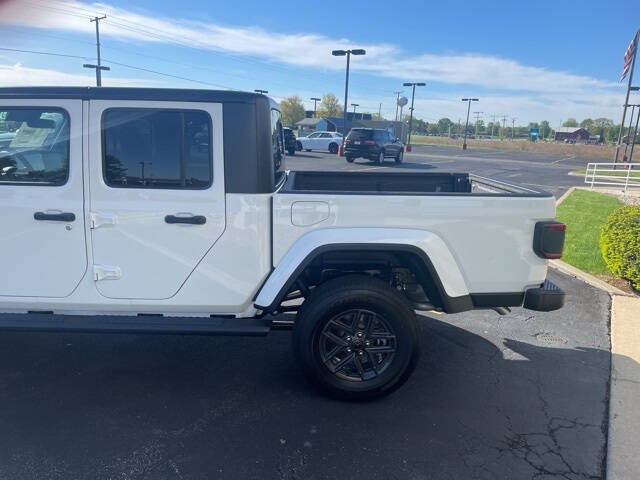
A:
89 100 225 299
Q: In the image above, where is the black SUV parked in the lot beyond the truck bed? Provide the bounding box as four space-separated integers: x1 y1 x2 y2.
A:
344 128 404 163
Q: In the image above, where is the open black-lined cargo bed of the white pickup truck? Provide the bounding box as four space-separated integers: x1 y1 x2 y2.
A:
280 171 551 197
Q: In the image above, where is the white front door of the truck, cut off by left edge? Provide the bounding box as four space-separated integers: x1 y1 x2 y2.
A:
0 100 87 297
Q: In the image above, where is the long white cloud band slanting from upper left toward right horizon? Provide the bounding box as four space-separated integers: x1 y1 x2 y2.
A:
0 0 623 120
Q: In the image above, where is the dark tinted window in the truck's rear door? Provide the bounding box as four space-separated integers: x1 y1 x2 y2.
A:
102 108 213 190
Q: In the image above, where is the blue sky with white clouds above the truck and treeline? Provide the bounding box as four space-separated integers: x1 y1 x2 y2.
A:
0 0 640 125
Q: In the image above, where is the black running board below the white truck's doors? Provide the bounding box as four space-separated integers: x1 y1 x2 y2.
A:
0 313 271 336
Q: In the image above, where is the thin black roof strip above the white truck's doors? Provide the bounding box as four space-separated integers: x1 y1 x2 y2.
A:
0 87 275 104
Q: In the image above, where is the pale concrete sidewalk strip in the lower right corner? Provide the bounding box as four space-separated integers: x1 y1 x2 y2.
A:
607 295 640 480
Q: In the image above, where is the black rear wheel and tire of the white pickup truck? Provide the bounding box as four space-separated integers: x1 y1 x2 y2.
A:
292 275 420 400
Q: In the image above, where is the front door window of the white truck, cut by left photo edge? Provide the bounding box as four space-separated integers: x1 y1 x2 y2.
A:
0 107 69 186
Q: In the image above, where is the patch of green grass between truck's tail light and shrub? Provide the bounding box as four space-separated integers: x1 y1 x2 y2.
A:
557 190 623 276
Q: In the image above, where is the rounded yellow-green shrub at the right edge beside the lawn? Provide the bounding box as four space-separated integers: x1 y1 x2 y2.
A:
600 205 640 289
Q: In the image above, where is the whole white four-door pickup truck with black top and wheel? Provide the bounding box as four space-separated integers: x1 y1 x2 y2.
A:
0 87 564 399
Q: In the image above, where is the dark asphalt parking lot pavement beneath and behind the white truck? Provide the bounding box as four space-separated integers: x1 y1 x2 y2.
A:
0 147 610 480
